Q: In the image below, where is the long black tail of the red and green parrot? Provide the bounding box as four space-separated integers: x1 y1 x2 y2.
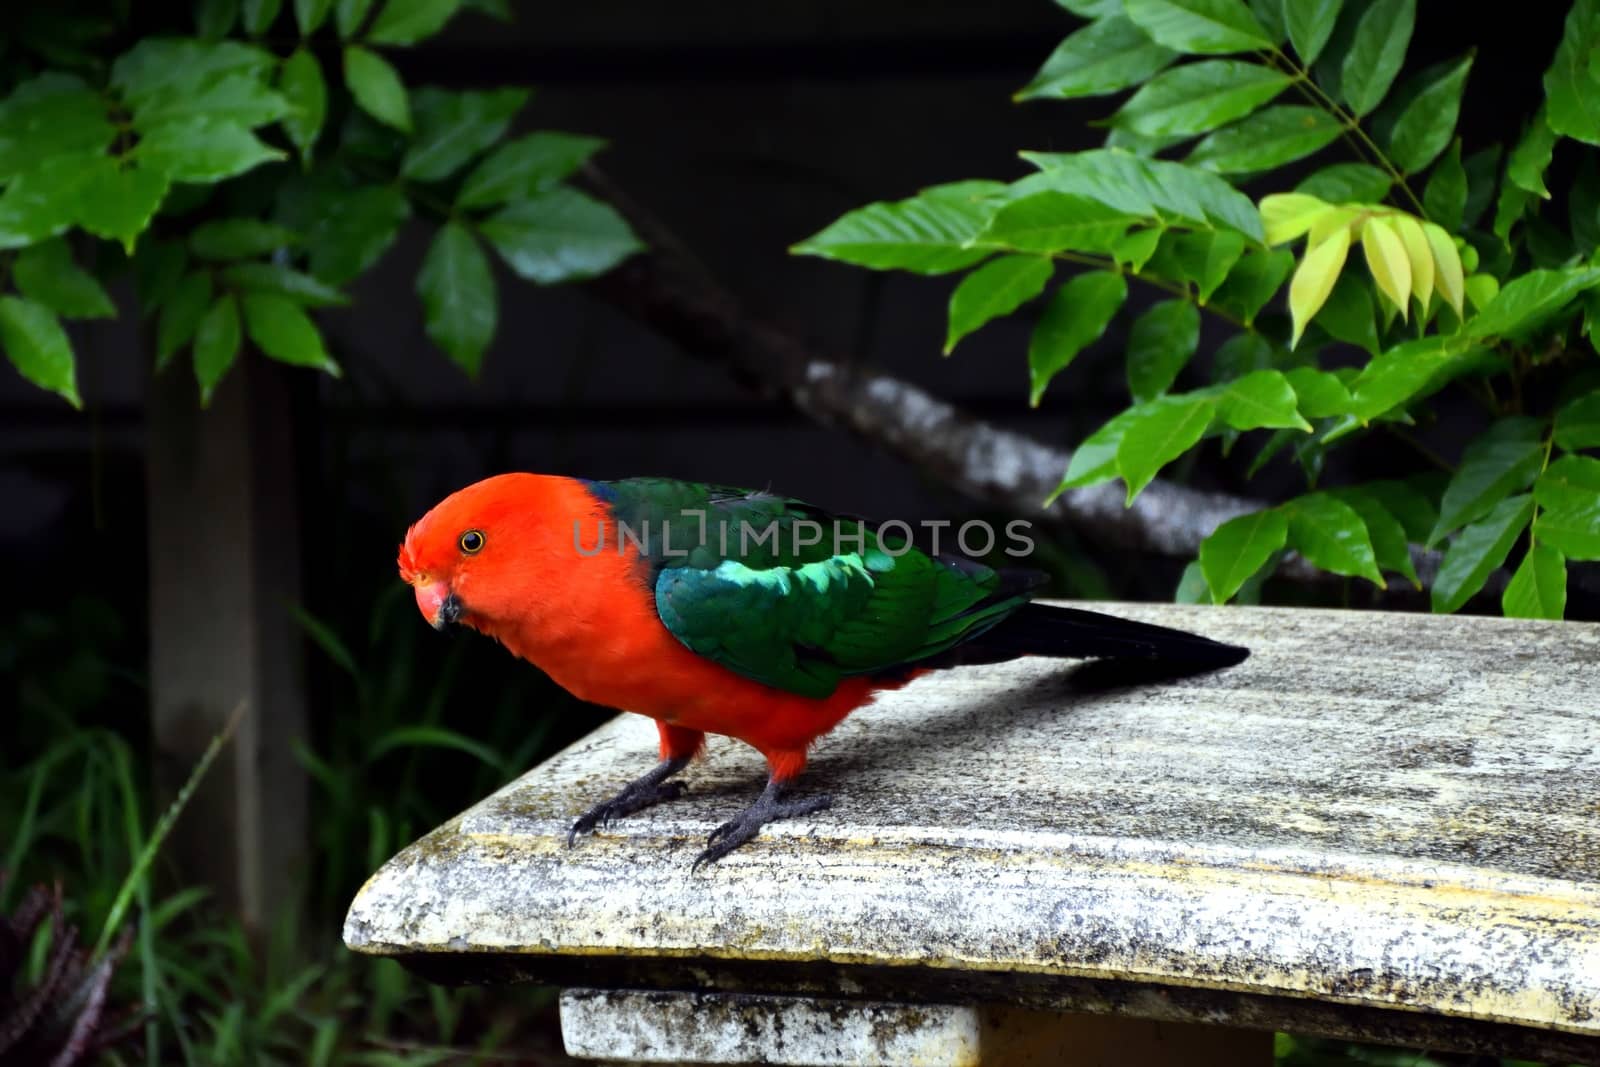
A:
915 603 1250 670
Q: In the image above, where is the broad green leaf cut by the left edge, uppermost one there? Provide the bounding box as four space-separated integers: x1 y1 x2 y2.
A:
0 70 117 181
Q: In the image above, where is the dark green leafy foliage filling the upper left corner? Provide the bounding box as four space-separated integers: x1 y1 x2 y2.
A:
0 0 640 406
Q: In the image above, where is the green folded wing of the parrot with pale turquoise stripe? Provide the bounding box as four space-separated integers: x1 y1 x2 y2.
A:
590 478 1032 697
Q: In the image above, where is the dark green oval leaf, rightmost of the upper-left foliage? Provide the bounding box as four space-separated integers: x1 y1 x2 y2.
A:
478 187 643 285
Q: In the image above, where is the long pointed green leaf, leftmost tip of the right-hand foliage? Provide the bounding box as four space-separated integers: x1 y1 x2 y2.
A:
790 182 1005 274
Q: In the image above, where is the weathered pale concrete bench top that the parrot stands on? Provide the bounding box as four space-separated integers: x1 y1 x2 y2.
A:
346 605 1600 1061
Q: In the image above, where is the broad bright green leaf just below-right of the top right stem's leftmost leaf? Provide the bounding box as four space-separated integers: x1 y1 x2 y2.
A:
1112 59 1290 138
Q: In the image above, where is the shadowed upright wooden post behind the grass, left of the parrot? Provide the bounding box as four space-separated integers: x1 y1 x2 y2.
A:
146 358 307 933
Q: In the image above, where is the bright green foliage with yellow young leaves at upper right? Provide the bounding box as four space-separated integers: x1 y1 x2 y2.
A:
795 0 1600 617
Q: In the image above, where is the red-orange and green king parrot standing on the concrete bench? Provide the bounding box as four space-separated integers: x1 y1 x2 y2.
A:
398 474 1250 867
